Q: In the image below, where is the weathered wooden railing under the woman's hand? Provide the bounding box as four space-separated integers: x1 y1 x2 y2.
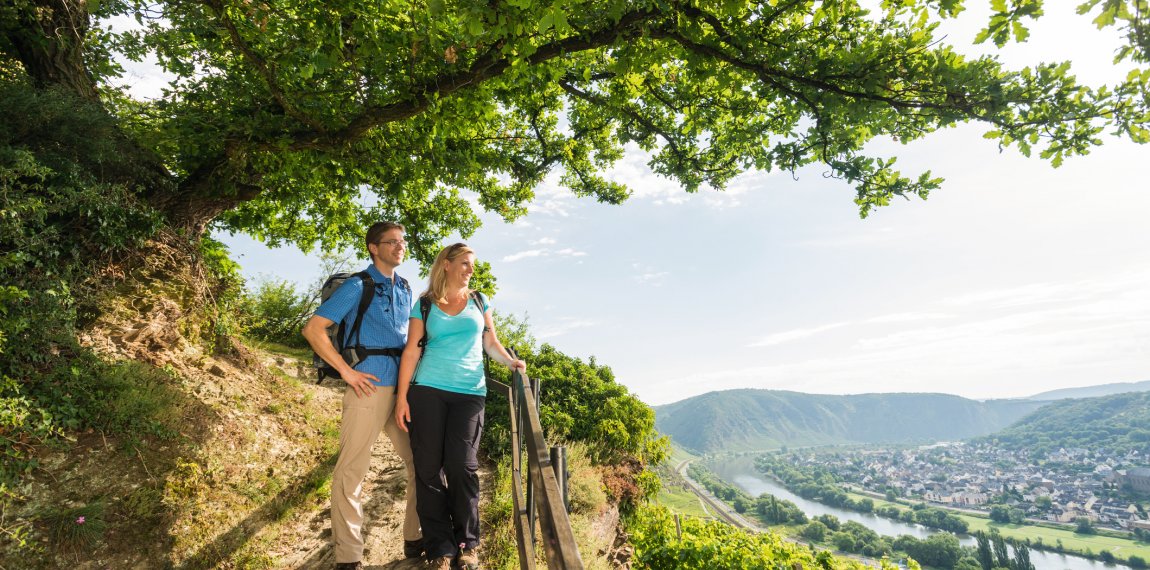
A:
488 353 583 570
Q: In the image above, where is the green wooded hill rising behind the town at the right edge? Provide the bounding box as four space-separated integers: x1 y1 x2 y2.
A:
986 392 1150 457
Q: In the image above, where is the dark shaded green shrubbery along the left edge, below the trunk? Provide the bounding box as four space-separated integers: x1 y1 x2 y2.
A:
0 82 167 482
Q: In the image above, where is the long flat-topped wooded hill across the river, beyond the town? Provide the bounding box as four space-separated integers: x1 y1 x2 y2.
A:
654 390 1048 453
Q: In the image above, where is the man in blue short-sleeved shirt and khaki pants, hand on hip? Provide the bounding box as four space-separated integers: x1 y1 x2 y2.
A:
304 222 421 570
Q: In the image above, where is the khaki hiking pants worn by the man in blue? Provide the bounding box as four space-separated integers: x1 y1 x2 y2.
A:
331 386 421 563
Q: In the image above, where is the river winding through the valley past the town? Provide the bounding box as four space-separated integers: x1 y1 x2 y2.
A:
706 456 1127 570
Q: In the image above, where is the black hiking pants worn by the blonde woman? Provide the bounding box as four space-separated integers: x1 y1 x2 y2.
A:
407 384 485 560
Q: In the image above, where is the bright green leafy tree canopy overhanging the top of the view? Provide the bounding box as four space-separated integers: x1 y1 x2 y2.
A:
33 0 1150 262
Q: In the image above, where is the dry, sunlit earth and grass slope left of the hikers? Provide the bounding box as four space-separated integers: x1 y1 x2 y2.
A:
0 246 423 569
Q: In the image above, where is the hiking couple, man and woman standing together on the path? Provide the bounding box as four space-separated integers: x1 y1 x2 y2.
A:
304 222 527 570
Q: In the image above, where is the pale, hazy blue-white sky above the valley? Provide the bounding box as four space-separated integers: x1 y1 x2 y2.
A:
109 2 1150 405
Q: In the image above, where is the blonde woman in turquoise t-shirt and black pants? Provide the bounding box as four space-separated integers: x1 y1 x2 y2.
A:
396 244 527 570
